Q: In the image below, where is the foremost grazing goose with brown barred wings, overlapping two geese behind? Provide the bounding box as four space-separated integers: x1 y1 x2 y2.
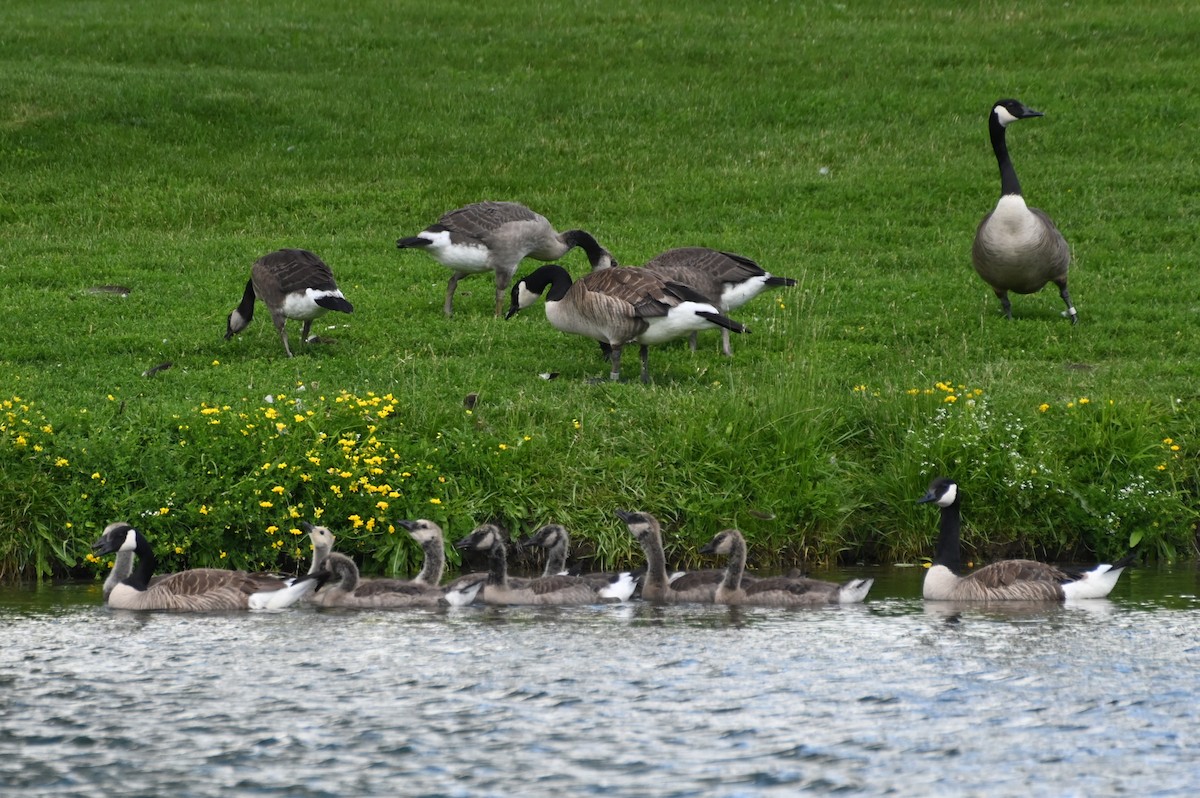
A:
506 264 749 383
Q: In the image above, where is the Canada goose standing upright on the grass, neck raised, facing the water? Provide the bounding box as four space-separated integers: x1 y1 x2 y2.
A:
971 100 1079 324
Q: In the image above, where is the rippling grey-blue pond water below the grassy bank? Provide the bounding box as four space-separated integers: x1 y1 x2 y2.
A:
0 569 1200 797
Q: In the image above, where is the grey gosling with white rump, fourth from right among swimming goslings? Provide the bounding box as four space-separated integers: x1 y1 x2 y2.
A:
455 523 636 605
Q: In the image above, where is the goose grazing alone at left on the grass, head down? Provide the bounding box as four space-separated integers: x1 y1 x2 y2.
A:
226 250 354 358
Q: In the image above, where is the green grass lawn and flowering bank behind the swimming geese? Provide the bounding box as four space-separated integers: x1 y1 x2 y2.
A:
0 0 1200 576
